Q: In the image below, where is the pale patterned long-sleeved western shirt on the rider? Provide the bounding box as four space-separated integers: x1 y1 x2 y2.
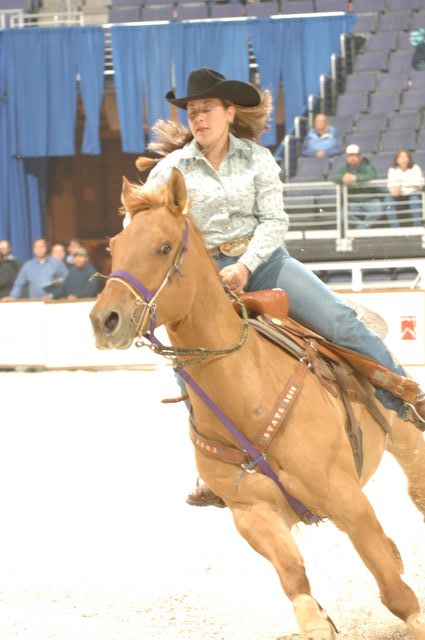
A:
146 134 288 272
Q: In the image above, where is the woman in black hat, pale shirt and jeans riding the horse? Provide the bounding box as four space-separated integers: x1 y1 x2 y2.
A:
133 68 425 506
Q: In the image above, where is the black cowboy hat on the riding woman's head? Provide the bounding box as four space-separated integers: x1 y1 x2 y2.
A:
165 67 260 109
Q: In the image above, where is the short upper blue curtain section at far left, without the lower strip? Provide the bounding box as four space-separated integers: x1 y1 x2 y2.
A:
4 27 104 157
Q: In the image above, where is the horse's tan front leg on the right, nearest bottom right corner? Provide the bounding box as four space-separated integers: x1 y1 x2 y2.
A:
327 477 425 640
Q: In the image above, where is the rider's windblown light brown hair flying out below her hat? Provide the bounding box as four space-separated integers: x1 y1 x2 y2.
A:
136 89 273 171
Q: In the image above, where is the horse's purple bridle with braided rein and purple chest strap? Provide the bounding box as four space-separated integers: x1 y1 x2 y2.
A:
103 215 321 524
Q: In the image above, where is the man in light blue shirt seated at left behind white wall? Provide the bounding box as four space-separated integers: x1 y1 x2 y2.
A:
6 238 68 300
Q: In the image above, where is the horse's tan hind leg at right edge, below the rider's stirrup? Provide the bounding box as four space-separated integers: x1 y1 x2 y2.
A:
387 420 425 517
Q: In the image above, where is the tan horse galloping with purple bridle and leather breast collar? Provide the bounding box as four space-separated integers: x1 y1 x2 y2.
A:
91 169 425 640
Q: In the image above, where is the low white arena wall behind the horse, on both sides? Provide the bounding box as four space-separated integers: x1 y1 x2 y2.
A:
0 289 425 381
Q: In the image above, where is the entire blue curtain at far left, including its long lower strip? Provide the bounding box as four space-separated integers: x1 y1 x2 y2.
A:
0 27 104 260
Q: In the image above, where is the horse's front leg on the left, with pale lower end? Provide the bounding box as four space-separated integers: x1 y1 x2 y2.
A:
230 503 335 640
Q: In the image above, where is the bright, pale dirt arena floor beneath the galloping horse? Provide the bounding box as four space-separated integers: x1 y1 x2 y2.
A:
0 366 425 640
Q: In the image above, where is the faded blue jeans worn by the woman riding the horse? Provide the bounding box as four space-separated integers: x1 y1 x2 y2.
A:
216 248 406 417
